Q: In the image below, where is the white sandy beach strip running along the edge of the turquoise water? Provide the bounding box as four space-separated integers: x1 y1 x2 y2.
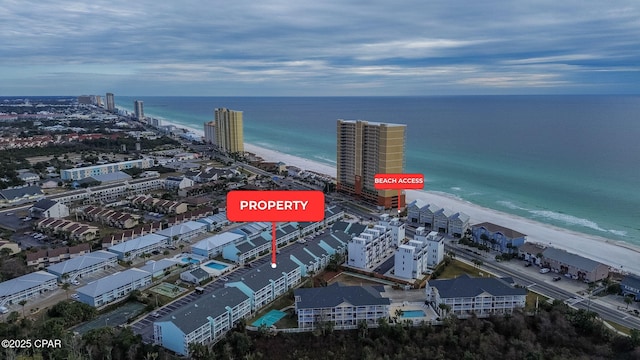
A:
155 119 640 274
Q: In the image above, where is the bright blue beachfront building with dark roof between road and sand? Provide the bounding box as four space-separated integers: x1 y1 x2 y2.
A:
471 222 527 254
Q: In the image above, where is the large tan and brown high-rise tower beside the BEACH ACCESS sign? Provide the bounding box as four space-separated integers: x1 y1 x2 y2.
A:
336 119 407 208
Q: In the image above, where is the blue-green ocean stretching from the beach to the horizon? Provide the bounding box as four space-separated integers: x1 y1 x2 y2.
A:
116 94 640 245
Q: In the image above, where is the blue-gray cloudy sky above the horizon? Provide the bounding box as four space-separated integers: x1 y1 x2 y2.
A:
0 0 640 96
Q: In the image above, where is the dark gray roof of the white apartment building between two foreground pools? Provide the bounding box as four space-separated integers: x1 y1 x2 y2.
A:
294 283 391 309
